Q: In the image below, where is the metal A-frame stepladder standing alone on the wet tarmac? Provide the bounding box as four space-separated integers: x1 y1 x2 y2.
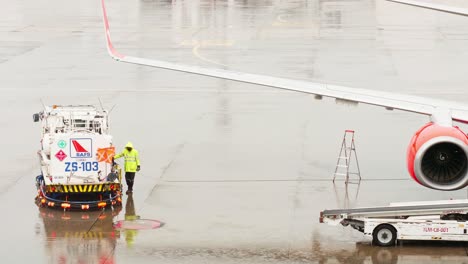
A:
333 129 361 184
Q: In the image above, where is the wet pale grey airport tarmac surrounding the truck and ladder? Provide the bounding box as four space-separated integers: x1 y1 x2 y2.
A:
0 0 468 263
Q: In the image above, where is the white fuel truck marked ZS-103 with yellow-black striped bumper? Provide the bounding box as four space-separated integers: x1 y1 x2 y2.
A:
33 105 122 210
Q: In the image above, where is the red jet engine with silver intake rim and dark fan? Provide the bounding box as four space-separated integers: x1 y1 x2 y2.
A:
407 123 468 191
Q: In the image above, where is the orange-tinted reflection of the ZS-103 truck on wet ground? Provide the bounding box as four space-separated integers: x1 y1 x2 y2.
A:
36 207 121 263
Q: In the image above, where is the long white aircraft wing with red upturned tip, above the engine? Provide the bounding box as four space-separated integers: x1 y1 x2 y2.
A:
101 0 468 124
